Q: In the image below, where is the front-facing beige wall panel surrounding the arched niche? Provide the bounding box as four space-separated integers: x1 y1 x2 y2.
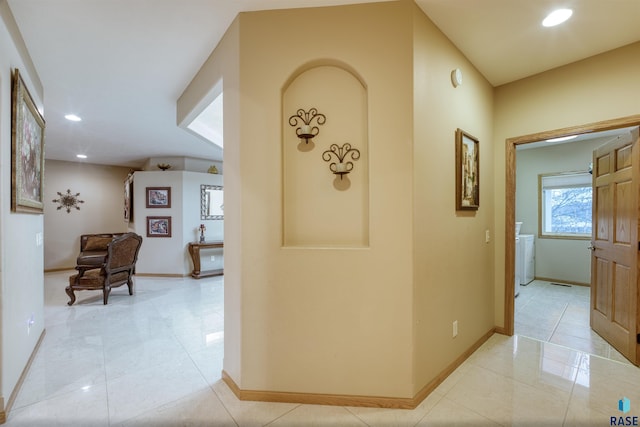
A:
238 2 413 397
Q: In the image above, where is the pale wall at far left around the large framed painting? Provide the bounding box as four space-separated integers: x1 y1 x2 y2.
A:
0 0 46 412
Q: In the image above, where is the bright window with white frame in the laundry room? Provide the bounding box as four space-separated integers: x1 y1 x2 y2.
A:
538 172 593 239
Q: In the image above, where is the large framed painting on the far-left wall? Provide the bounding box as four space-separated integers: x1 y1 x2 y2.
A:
11 69 45 214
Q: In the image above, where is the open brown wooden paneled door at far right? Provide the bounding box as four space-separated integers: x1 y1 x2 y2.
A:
591 128 640 364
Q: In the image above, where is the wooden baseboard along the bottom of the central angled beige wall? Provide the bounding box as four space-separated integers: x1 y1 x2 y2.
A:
222 328 496 409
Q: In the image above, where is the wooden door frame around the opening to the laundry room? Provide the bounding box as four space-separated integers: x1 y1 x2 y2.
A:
497 114 640 336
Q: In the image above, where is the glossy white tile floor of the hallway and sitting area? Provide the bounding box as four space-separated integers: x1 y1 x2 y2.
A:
6 273 640 427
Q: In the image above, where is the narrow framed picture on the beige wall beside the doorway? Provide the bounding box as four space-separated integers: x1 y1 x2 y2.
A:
456 129 480 210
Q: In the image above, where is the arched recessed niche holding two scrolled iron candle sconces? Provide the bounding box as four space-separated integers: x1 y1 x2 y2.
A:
282 59 369 248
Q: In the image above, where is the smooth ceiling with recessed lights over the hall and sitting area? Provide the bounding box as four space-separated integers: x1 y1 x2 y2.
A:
8 0 640 167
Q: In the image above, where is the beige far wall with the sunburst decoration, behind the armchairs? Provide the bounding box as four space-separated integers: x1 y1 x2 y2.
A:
44 160 130 271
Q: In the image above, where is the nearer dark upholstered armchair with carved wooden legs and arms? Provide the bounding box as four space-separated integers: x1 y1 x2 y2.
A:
65 233 142 305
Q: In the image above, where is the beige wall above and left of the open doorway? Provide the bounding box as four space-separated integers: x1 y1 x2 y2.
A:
494 43 640 326
